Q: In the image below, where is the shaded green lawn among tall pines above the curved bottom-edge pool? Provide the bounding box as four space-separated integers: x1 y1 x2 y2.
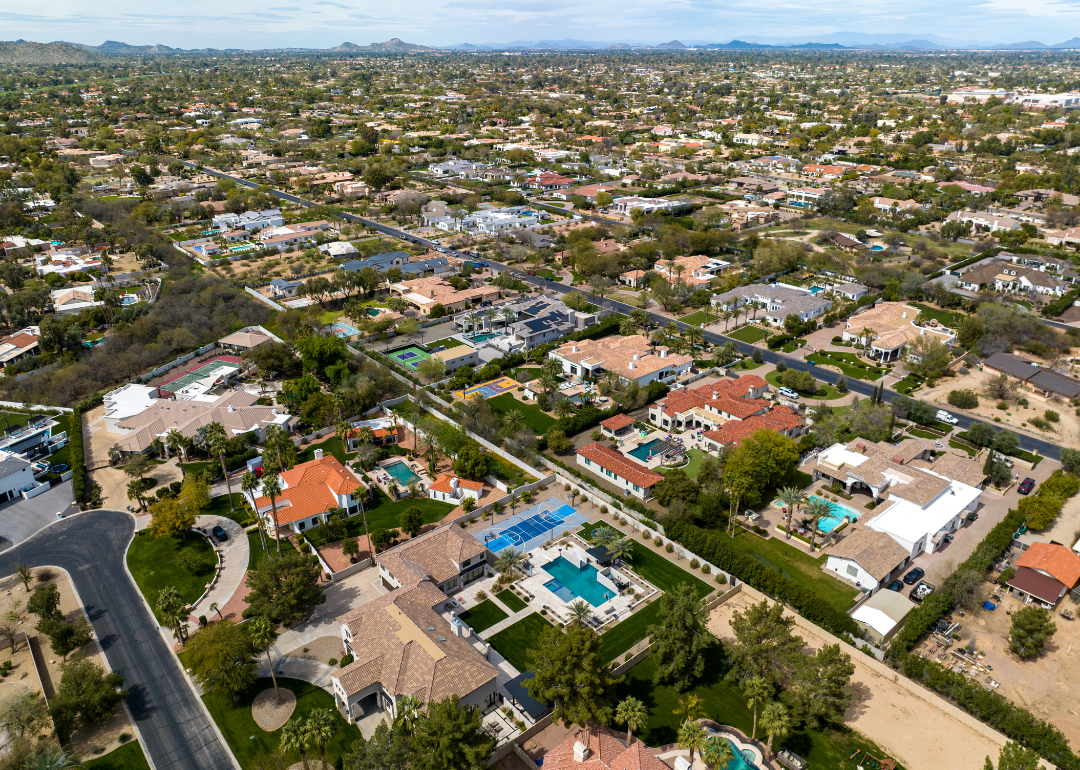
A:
615 645 901 768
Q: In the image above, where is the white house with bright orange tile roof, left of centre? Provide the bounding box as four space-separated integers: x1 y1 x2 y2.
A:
246 449 368 538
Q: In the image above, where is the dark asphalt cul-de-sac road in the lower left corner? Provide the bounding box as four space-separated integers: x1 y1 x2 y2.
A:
0 511 233 770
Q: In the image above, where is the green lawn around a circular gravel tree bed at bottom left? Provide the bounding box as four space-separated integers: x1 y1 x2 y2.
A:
203 677 361 770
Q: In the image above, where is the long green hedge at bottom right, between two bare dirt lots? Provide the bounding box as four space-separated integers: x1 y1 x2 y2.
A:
903 656 1080 770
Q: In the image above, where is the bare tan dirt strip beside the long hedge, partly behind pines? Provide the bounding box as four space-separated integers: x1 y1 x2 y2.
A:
708 594 1002 770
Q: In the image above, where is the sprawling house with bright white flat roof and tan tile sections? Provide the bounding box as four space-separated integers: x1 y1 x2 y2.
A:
811 438 986 558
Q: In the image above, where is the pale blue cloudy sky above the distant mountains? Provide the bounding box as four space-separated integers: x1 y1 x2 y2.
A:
6 0 1080 49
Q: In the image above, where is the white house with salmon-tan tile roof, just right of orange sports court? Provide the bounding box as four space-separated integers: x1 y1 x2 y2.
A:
548 335 693 386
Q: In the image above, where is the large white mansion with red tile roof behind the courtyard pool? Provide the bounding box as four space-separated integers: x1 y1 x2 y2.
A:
649 375 770 431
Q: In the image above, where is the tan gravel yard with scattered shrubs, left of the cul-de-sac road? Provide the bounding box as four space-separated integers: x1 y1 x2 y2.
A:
0 567 135 758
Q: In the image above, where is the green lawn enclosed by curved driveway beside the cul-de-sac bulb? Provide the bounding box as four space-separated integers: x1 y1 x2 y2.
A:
127 532 217 621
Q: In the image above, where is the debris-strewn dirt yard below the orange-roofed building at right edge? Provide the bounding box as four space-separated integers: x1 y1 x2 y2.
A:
960 584 1080 746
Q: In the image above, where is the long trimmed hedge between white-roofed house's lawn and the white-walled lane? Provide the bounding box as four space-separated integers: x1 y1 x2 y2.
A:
664 521 859 636
